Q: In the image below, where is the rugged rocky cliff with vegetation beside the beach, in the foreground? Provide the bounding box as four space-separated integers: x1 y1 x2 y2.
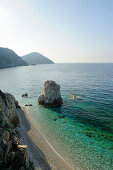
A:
0 90 34 170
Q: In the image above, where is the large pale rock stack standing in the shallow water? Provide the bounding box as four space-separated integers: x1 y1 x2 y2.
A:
38 80 63 107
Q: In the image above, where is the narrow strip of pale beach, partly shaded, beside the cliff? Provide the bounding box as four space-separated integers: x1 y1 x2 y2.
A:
17 107 77 170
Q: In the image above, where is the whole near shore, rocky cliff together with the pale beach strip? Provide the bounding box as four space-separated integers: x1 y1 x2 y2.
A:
0 91 76 170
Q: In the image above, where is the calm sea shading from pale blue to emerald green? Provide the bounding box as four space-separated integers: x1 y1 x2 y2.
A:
0 64 113 170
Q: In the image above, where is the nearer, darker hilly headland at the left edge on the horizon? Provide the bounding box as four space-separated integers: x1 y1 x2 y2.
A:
0 47 28 68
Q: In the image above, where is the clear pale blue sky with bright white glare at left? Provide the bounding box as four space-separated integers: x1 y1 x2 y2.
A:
0 0 113 63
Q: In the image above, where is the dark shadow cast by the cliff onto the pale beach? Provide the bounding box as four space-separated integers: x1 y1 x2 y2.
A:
17 109 51 170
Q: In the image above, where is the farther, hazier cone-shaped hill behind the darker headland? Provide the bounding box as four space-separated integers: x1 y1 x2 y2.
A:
22 52 54 64
